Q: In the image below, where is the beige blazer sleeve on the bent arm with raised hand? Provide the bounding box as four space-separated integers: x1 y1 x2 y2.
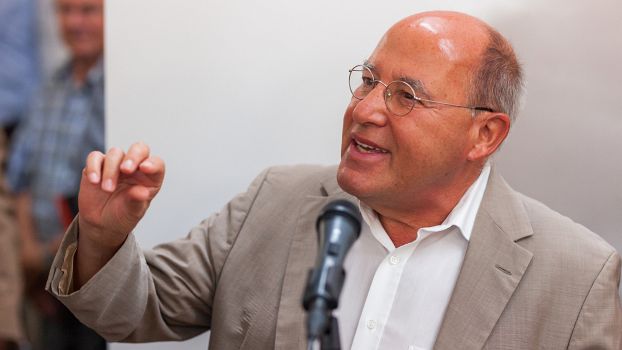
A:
46 170 268 342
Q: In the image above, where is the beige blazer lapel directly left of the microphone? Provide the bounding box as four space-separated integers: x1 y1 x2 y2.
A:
274 176 353 350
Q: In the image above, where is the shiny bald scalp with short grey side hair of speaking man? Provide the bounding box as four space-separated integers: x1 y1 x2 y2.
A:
379 11 522 119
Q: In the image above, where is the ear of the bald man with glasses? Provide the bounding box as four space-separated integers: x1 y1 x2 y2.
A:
467 113 510 161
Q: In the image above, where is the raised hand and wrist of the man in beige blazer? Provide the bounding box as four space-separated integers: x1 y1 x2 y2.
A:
74 143 164 287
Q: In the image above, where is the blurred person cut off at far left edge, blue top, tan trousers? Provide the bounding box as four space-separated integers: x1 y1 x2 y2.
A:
0 0 40 350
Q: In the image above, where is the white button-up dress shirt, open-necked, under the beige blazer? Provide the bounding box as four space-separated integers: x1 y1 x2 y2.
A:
335 163 490 350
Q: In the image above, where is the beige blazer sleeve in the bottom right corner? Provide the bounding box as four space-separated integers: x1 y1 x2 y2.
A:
568 251 622 350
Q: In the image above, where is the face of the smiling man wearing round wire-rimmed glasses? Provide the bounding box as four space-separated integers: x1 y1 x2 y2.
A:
337 15 485 209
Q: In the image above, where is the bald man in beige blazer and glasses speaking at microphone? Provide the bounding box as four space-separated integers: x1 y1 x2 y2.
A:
47 12 622 350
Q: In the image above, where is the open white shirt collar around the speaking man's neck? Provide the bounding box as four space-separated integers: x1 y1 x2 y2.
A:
359 162 490 247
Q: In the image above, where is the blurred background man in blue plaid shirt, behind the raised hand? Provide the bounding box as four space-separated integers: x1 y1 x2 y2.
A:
7 0 106 350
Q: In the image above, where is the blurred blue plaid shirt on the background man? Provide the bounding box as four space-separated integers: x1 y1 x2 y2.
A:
7 60 105 241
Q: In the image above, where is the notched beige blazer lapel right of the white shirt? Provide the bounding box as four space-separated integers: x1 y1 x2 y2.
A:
434 168 533 349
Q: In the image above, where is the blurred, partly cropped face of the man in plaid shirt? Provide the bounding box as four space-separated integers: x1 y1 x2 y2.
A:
56 0 104 60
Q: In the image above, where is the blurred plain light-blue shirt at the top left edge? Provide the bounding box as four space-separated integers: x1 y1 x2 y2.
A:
0 0 40 127
